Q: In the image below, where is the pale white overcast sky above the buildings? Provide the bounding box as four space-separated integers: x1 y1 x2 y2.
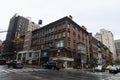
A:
0 0 120 40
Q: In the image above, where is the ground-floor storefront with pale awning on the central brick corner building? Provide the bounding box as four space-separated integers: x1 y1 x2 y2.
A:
41 48 74 68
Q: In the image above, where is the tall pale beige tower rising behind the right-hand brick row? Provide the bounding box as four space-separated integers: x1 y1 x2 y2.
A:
95 29 117 60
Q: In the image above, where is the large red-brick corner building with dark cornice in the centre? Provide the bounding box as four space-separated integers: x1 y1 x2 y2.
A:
31 17 90 68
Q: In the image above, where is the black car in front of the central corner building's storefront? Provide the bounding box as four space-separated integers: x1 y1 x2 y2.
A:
43 61 60 70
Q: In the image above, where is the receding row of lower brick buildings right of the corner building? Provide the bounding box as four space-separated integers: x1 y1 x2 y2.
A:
90 34 113 66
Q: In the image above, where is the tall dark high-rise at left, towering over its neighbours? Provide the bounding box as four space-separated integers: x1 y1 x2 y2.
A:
3 14 29 59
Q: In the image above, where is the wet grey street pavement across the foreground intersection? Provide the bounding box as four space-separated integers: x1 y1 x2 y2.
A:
0 66 120 80
